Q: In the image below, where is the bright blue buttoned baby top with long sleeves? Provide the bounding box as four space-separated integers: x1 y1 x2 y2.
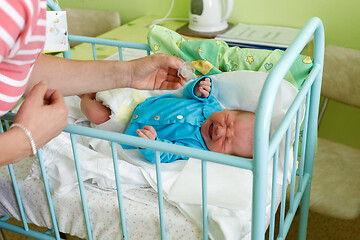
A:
122 77 223 163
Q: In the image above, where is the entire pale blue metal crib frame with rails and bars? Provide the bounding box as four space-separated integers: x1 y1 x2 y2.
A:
0 0 324 240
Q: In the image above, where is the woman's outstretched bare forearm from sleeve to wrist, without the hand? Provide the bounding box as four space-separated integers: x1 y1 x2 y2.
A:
26 55 130 96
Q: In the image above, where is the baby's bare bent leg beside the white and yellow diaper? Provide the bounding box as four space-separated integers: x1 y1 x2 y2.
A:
80 93 111 125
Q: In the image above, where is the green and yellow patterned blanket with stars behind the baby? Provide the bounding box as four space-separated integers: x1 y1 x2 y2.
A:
148 25 313 88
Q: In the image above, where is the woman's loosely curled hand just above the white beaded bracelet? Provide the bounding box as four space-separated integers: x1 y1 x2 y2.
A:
12 82 68 149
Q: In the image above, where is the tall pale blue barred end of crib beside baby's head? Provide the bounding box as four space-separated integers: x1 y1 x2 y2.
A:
251 17 325 239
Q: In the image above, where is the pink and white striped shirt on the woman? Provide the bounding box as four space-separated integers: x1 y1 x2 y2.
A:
0 0 46 116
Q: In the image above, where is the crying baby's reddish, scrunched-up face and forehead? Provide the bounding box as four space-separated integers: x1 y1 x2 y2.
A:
201 110 255 157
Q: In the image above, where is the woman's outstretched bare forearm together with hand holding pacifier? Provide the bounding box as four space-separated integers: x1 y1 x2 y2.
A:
25 53 185 96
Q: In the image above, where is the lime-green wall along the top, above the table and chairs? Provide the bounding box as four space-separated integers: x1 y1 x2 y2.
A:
58 0 360 49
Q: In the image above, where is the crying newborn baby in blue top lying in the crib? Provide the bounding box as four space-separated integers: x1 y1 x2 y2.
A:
81 76 255 163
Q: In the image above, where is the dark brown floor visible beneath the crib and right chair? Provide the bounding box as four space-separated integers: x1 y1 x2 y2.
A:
0 211 360 240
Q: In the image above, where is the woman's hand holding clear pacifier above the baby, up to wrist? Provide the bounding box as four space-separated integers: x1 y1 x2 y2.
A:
130 53 185 90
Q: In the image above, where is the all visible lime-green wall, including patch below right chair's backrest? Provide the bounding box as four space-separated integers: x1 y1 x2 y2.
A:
58 0 360 148
